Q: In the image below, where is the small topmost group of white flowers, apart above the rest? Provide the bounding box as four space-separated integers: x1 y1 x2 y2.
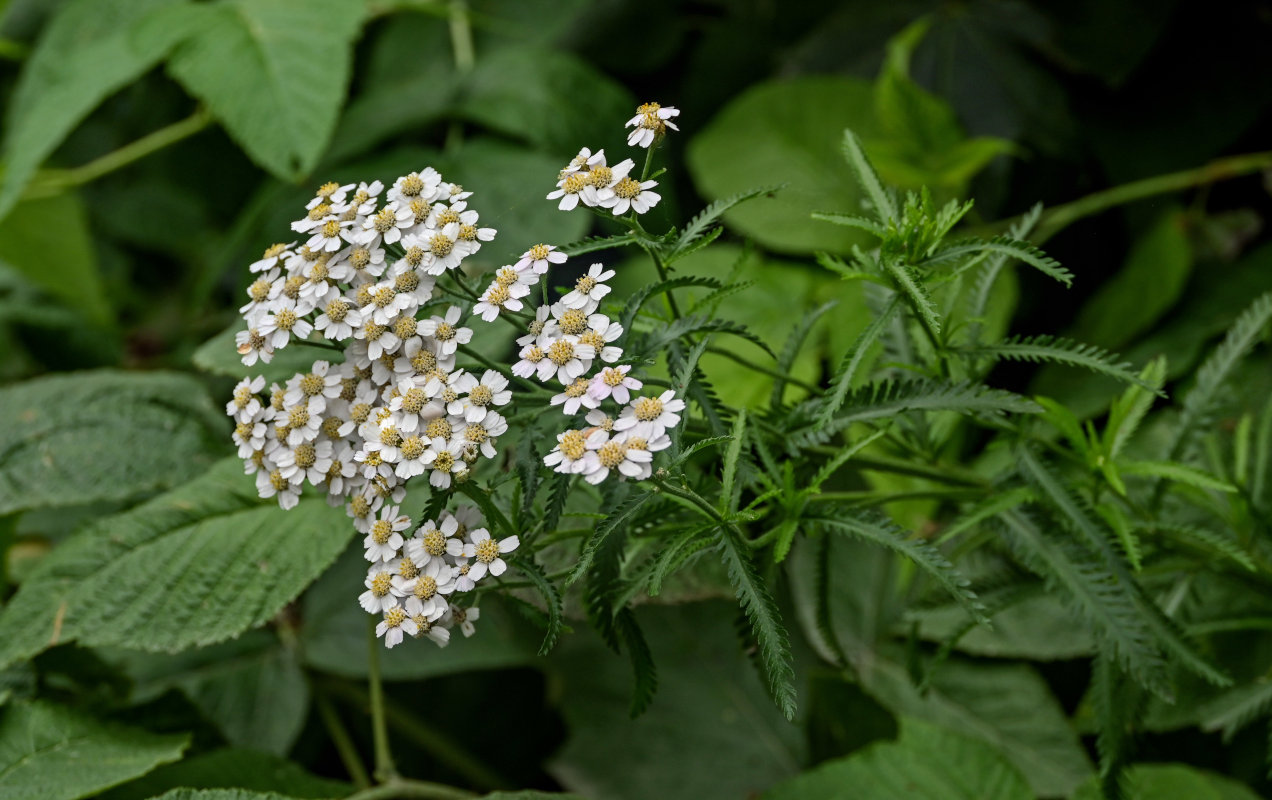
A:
547 103 681 216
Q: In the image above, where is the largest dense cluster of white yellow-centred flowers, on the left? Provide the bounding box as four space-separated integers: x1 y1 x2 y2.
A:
226 168 518 646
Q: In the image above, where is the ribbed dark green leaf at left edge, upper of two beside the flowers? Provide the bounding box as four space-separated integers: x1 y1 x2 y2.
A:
0 370 229 514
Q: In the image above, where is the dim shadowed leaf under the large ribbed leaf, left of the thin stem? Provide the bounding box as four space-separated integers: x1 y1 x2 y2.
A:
104 631 309 755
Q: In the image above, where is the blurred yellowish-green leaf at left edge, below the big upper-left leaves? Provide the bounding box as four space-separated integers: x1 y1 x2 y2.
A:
0 193 111 326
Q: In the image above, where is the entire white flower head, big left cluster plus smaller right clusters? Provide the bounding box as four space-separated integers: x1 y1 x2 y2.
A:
225 103 684 647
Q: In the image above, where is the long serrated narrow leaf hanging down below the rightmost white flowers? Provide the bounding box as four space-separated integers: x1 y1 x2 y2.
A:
716 525 795 720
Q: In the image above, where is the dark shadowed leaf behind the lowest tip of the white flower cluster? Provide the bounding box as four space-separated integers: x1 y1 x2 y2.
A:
300 544 543 680
